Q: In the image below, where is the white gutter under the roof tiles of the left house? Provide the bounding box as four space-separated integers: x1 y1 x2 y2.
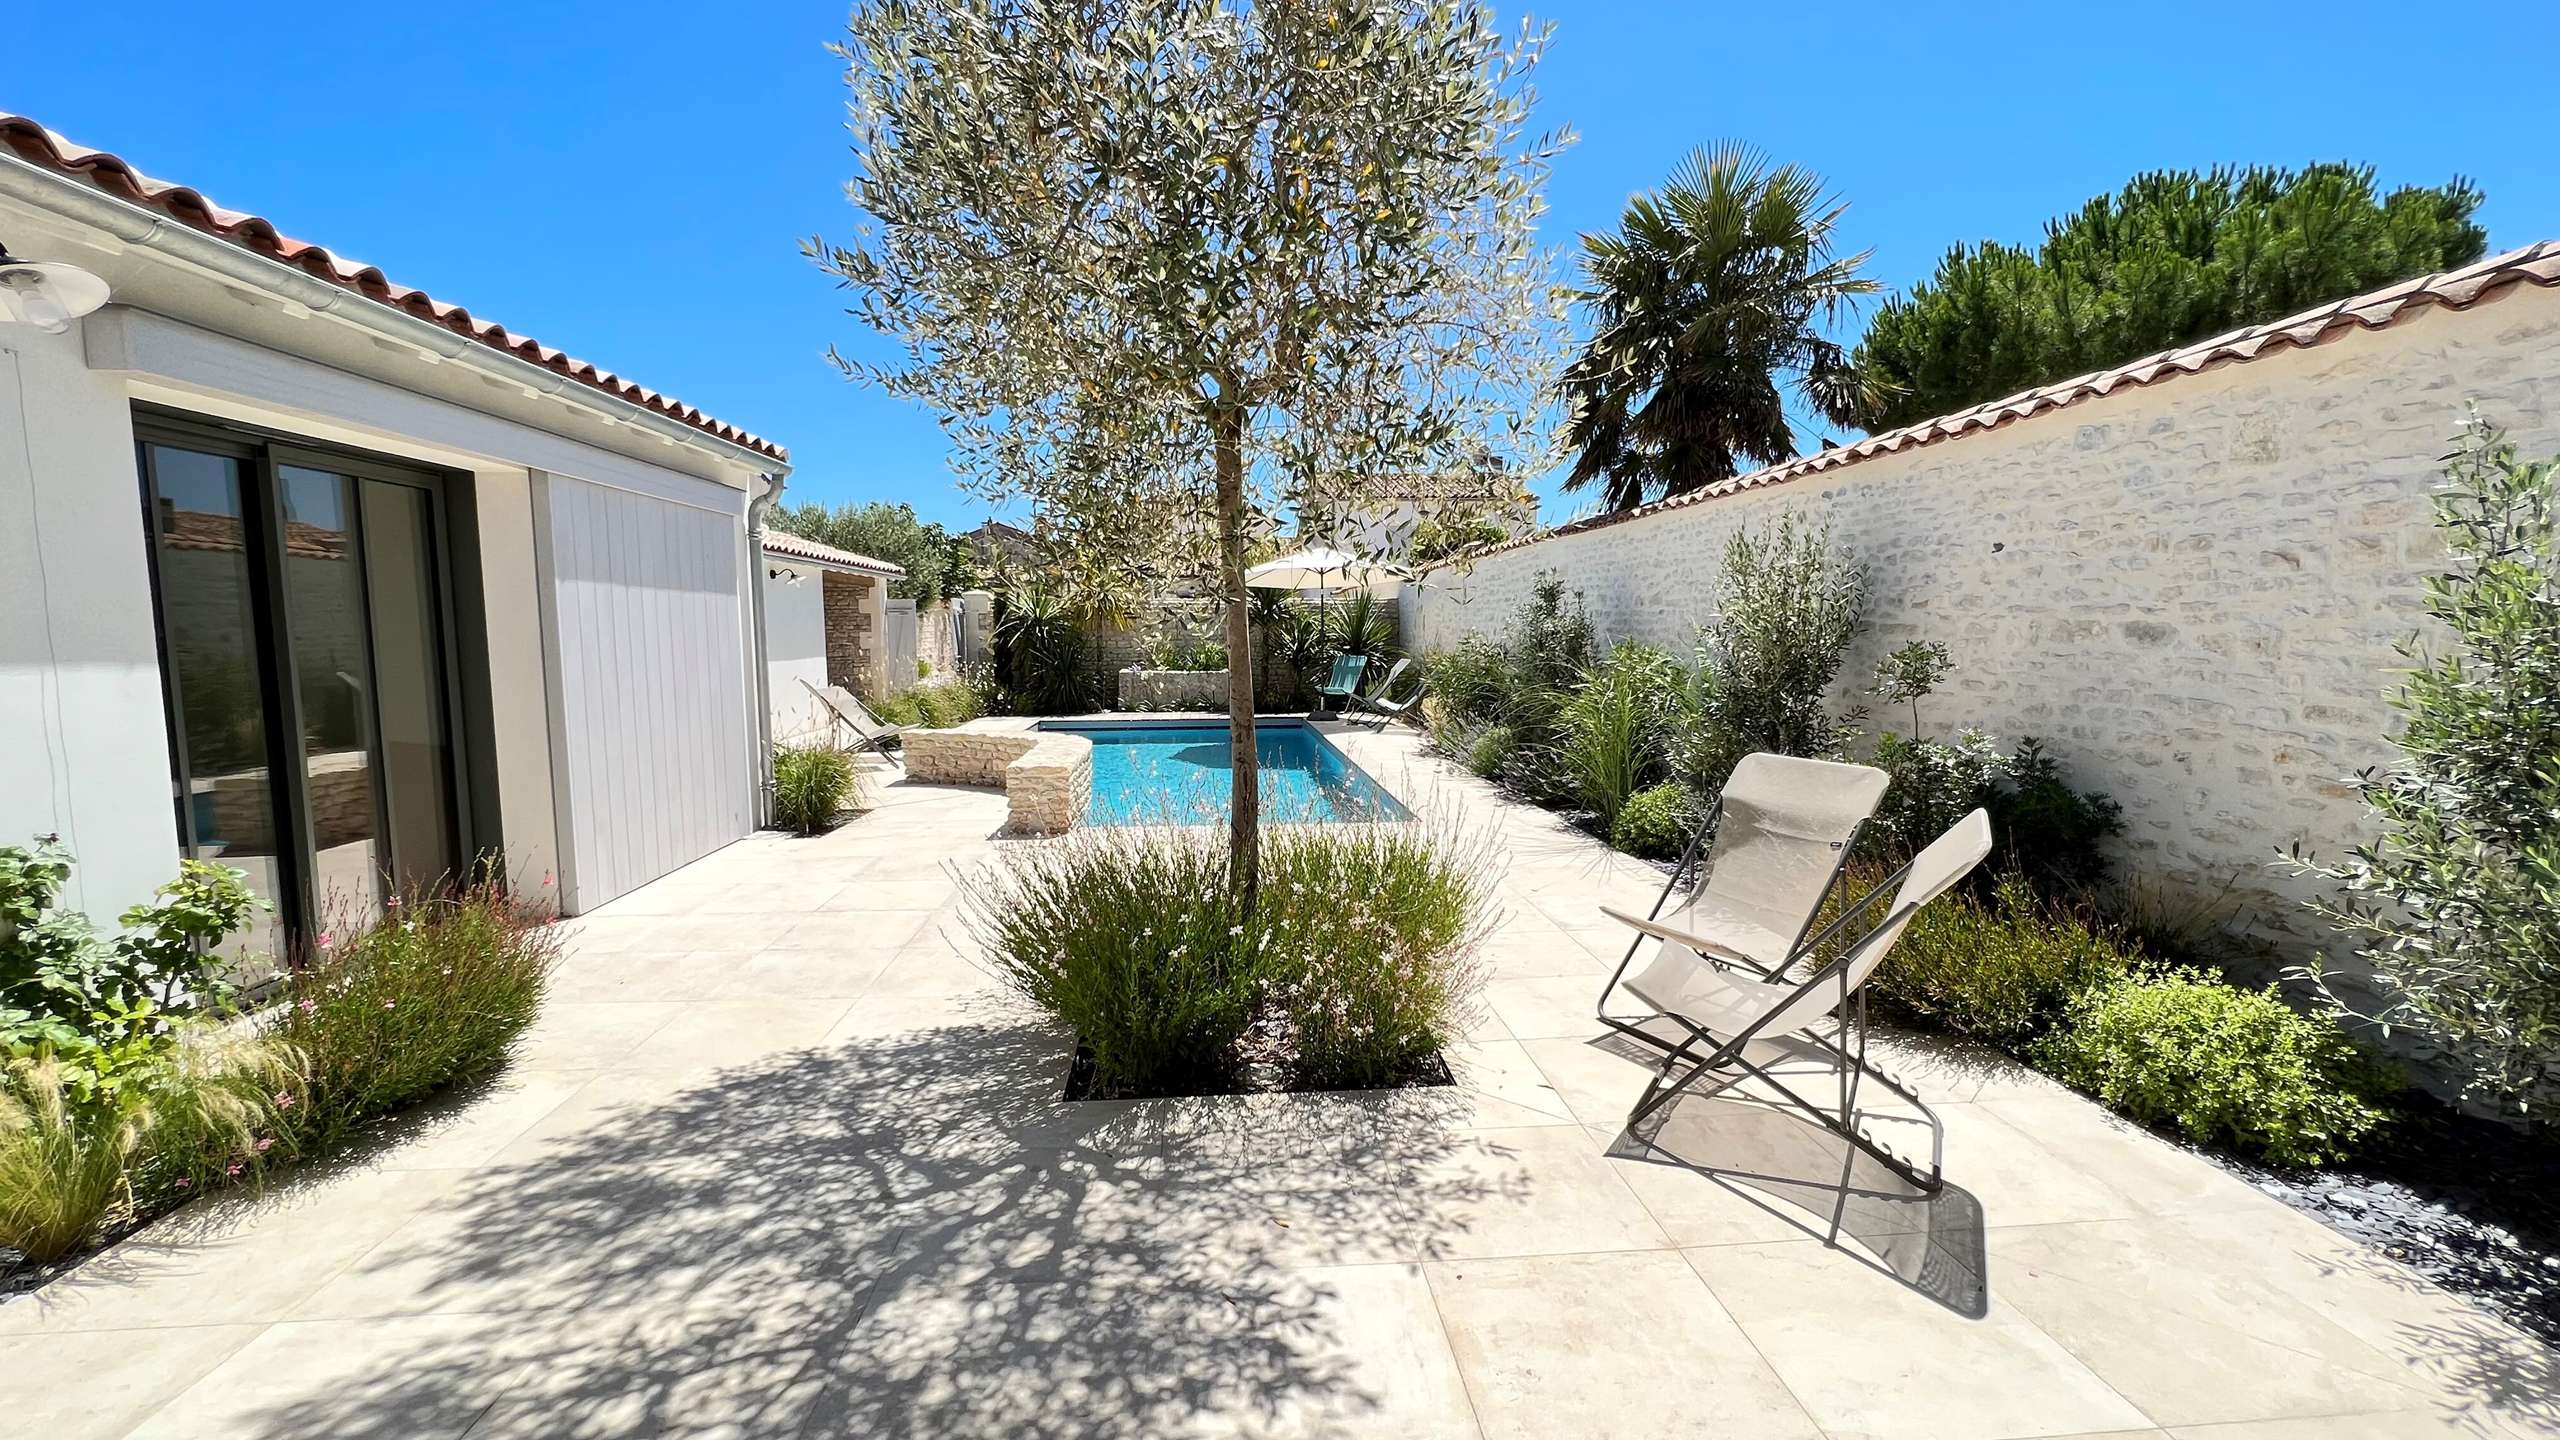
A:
0 151 786 477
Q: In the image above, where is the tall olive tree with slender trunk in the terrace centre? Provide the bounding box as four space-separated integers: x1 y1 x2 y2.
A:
812 0 1564 897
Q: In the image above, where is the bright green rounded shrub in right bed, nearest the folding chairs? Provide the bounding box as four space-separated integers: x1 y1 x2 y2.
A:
2035 976 2386 1166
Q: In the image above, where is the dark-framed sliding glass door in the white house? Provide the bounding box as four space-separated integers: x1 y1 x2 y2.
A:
138 418 463 953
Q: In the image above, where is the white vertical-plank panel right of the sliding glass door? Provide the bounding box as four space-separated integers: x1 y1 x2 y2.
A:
532 474 758 912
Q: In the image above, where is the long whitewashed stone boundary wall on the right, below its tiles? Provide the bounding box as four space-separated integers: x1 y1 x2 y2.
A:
1403 287 2560 958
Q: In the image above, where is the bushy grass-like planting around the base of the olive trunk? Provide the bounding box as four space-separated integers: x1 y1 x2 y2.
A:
965 825 1490 1097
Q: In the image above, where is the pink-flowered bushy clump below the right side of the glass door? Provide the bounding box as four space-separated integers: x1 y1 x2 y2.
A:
269 879 561 1153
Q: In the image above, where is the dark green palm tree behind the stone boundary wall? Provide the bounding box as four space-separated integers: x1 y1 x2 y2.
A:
1564 146 1879 510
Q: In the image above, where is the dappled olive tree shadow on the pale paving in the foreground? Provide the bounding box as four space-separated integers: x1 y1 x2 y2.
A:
220 1002 1526 1440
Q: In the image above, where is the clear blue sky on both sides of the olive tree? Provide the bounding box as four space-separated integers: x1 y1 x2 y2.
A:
0 0 2560 525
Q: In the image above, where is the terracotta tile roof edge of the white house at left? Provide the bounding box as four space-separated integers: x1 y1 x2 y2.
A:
0 110 791 461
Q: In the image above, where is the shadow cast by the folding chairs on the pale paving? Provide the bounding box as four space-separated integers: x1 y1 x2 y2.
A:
1595 1035 1992 1320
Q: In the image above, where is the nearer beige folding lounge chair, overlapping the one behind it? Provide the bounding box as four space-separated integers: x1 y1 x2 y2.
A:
1626 810 1992 1194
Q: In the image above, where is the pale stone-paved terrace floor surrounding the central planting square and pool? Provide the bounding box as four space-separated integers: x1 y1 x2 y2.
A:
0 735 2555 1440
